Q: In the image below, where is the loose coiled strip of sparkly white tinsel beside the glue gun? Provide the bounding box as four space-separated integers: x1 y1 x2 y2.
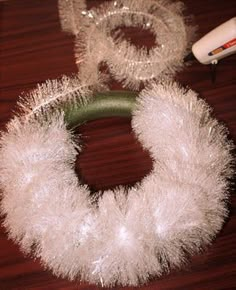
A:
59 0 195 89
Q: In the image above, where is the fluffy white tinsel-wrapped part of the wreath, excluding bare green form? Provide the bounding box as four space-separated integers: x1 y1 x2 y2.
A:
0 80 231 286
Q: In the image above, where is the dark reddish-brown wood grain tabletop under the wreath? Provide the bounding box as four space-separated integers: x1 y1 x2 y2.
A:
0 0 236 290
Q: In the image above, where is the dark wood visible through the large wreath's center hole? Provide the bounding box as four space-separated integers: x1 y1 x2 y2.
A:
75 117 152 193
